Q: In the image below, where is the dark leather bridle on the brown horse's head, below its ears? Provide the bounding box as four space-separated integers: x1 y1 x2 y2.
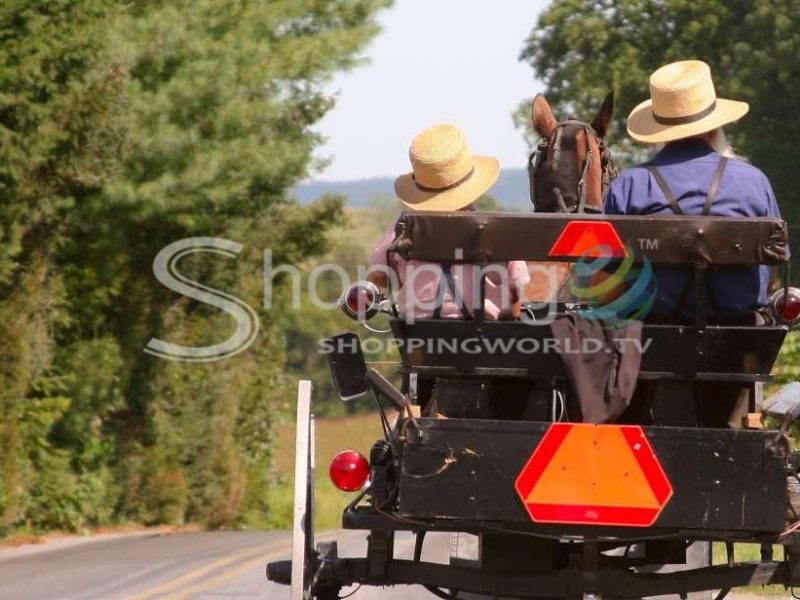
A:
528 118 617 213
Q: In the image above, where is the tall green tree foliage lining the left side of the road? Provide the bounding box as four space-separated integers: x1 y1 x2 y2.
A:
0 0 387 533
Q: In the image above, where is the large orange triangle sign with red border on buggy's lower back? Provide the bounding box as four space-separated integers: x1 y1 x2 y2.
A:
515 423 672 527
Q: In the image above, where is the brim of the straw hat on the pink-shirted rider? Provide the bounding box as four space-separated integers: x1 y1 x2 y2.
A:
394 156 500 211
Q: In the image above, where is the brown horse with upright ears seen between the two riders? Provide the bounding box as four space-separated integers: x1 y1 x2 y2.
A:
524 91 616 302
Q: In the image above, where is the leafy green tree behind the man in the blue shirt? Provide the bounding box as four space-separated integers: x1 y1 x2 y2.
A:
521 0 800 220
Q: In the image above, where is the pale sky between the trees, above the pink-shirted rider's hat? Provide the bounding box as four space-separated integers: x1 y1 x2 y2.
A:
313 0 547 181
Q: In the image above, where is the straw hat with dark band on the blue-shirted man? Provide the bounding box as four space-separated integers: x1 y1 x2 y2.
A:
628 60 750 144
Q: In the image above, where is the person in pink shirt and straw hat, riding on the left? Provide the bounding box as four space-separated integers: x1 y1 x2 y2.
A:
369 125 530 321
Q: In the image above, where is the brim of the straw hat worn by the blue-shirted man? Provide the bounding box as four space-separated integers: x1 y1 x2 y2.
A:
628 98 750 144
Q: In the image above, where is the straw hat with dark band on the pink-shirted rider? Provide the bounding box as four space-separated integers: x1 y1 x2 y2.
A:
394 125 500 211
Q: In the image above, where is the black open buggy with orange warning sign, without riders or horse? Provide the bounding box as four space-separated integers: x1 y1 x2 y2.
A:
267 213 800 600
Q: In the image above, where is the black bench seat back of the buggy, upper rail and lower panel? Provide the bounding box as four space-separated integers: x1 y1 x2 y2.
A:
392 212 788 381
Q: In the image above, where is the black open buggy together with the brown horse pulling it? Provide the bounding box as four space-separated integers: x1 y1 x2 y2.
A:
267 82 800 600
